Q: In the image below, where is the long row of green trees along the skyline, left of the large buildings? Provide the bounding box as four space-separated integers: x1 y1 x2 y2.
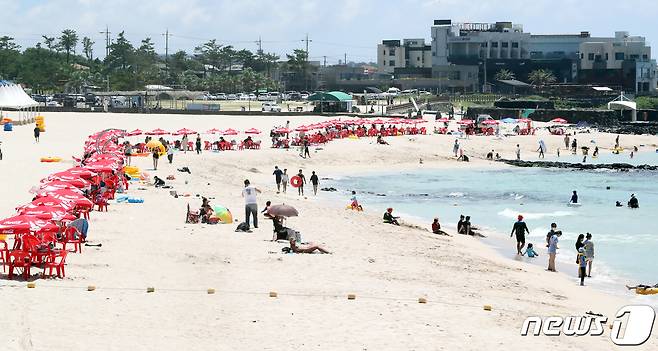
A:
0 29 313 92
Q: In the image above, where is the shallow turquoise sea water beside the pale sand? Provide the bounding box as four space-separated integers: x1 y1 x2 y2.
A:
323 155 658 287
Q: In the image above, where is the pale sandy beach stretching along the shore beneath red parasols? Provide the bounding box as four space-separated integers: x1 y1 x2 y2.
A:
0 113 658 350
